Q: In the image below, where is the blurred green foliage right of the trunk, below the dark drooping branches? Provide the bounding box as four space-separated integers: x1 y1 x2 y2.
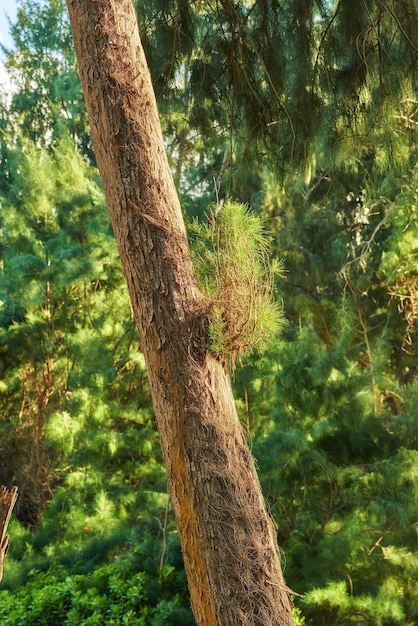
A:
235 134 418 626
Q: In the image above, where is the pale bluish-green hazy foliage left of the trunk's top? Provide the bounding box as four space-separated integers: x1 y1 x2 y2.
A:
5 0 92 152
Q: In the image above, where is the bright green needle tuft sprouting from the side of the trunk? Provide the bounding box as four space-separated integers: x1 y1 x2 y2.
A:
191 202 283 368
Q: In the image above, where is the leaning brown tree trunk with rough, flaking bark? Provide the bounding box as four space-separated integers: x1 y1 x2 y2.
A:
67 0 293 626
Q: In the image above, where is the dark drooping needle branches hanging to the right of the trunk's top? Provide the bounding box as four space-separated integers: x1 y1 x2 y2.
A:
135 0 418 199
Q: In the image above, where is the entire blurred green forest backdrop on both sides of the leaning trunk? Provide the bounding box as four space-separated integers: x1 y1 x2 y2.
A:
0 0 418 626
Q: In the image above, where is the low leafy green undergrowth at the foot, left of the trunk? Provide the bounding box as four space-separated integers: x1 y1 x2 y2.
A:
0 511 195 626
